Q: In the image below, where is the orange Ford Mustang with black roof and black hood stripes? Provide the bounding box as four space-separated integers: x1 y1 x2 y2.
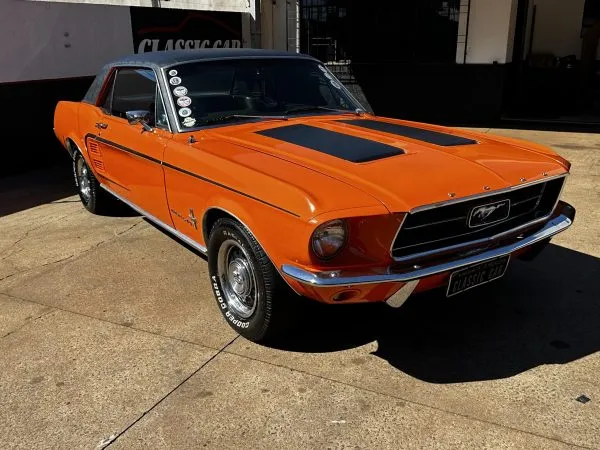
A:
54 50 575 341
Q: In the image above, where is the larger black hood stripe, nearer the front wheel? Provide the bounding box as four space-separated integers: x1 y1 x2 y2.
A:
256 125 404 163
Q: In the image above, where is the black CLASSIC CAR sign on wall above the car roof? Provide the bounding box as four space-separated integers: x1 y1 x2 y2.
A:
131 7 242 53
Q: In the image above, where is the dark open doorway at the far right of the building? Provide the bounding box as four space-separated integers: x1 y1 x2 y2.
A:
503 0 600 125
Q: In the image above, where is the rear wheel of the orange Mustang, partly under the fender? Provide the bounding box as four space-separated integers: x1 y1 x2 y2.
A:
73 152 119 214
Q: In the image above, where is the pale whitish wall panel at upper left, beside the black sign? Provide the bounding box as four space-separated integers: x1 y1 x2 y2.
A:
0 0 133 82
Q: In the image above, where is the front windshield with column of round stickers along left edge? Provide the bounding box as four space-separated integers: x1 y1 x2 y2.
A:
165 58 362 130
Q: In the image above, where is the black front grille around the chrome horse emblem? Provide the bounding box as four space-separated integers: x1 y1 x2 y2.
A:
392 178 564 259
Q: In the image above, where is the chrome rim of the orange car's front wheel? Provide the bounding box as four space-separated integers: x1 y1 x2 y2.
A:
217 239 260 319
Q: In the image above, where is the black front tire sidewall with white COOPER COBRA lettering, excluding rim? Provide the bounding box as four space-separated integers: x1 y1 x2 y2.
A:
208 219 269 338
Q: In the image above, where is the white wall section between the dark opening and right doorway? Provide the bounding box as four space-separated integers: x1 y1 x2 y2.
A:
456 0 516 64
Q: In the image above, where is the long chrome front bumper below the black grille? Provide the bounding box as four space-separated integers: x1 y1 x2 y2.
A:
281 214 573 287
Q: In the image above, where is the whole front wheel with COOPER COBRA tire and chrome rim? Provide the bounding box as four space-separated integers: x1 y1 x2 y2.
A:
208 218 299 342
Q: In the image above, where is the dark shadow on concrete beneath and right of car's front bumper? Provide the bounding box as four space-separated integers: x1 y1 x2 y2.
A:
278 245 600 383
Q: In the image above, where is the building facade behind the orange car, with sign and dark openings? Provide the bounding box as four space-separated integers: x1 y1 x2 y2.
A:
0 0 600 172
